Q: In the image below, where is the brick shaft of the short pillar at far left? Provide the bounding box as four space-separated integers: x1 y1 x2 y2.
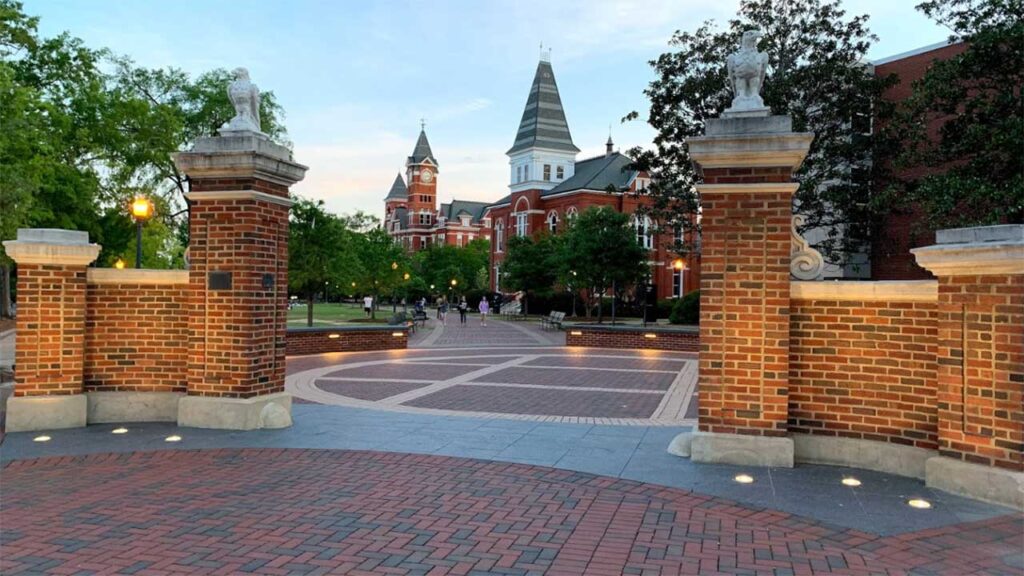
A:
14 263 85 396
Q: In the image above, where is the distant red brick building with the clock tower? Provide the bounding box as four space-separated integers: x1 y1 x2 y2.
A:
384 129 490 251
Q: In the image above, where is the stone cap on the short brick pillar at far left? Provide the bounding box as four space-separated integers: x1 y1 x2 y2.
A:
3 228 100 266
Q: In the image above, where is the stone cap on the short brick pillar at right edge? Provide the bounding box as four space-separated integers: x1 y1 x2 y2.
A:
910 224 1024 276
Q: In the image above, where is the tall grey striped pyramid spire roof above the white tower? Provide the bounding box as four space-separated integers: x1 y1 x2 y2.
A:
506 60 580 154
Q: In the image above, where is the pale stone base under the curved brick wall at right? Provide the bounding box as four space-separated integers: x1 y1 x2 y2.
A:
791 434 938 479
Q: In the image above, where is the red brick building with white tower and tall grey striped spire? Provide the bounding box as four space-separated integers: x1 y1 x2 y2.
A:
485 58 699 298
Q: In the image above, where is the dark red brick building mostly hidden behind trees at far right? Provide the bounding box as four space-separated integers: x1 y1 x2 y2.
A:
871 42 967 280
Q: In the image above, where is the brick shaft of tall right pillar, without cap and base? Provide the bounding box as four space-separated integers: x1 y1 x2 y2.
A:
699 179 796 436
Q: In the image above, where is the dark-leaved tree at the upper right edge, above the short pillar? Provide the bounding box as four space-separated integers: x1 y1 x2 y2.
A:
877 0 1024 230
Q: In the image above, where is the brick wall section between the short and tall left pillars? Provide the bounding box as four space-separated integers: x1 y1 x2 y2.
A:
84 283 188 393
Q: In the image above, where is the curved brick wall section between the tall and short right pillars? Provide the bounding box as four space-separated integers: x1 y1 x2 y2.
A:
788 295 938 449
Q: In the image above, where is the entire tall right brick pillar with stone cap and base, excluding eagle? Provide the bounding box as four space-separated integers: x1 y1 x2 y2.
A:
689 116 812 466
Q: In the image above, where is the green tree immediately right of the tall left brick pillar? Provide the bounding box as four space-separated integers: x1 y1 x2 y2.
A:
288 198 360 326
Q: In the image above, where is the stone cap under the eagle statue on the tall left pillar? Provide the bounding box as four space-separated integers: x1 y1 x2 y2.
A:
174 131 309 187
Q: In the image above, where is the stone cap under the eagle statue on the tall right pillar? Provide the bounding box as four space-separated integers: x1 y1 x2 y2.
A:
686 116 814 170
